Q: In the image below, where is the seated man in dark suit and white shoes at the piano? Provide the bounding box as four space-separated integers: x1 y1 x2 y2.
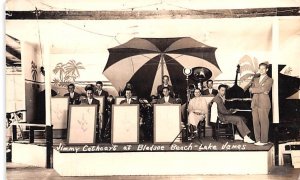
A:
212 84 254 143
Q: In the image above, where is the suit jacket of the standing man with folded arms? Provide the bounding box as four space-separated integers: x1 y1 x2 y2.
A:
251 75 273 109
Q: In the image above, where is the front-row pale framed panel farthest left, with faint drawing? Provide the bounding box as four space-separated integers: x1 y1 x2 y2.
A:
67 105 98 144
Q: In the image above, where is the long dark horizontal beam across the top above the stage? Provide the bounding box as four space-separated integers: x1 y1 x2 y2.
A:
6 7 300 20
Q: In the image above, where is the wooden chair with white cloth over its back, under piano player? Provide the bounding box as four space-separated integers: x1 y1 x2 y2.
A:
209 102 234 141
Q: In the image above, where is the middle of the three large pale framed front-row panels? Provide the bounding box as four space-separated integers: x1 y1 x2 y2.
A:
111 104 139 144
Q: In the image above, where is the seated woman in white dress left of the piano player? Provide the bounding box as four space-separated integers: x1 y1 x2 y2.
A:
188 88 208 138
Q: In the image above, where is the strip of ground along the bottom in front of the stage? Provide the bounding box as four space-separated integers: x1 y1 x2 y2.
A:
5 163 300 180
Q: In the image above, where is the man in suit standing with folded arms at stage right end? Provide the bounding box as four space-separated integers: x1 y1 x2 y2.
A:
249 63 273 146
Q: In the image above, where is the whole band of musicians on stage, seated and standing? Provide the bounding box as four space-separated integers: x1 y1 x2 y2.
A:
64 63 273 145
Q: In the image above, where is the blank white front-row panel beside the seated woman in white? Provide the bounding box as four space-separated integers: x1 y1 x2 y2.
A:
153 104 181 144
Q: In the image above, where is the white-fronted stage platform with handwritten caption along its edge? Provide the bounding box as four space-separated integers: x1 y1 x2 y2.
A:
53 138 274 176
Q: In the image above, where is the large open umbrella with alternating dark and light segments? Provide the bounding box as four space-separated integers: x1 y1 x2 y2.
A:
103 37 220 101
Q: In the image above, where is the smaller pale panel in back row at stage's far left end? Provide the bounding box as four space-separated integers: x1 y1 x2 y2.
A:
51 97 69 129
